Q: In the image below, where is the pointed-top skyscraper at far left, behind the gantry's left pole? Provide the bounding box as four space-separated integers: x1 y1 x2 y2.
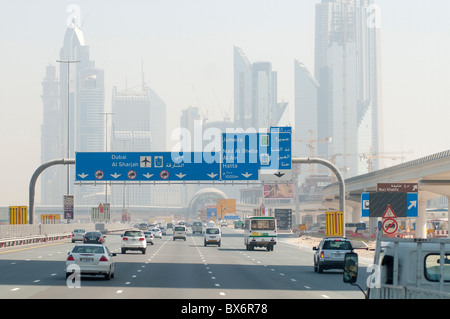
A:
41 20 105 209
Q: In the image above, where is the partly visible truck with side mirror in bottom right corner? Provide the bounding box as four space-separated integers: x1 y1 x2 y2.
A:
343 222 450 299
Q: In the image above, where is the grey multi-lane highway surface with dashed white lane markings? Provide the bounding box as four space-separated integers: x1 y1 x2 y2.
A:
0 227 367 300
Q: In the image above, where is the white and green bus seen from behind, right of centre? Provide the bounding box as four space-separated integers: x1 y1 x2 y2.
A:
244 216 277 251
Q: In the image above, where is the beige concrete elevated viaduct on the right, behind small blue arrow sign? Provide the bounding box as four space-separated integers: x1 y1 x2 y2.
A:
322 150 450 238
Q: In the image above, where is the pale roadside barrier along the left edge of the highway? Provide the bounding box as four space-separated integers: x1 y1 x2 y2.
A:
0 223 131 248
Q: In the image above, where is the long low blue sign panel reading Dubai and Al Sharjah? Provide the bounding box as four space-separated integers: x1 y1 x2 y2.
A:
75 152 220 182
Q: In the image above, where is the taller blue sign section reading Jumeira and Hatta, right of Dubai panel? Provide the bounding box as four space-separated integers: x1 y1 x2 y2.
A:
221 127 292 180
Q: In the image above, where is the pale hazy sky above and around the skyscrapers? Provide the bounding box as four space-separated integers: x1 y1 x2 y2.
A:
0 0 450 206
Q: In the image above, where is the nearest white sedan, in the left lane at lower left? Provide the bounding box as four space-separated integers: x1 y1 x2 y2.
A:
66 244 116 280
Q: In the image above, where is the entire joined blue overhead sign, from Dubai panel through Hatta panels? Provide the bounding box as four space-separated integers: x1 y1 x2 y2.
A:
75 127 292 182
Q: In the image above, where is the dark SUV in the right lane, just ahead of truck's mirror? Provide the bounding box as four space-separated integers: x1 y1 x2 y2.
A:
313 237 353 273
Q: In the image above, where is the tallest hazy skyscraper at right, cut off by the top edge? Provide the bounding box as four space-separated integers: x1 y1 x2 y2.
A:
314 0 382 177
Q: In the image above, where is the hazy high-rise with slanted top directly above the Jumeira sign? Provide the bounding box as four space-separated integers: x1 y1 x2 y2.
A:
234 46 287 131
